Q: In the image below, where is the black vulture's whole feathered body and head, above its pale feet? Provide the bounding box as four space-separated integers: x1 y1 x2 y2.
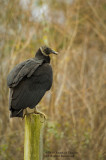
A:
7 46 57 117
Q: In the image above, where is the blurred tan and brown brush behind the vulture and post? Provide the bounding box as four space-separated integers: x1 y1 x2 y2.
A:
0 0 106 160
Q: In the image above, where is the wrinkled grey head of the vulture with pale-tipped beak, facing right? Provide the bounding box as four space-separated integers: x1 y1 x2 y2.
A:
40 46 58 56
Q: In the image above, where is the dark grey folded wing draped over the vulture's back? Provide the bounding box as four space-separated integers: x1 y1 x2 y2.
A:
7 59 43 88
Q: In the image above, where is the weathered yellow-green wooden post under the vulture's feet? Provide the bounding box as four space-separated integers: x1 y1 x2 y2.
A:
24 114 44 160
